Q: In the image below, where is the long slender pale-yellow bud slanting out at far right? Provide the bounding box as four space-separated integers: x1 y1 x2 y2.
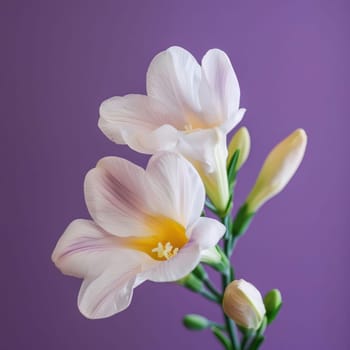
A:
246 129 307 213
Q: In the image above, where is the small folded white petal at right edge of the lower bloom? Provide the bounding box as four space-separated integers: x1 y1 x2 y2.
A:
190 217 226 249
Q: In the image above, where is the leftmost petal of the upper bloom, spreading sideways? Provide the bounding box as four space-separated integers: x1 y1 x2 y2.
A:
98 95 180 153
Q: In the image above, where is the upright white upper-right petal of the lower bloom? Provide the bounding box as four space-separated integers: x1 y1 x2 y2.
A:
146 152 205 227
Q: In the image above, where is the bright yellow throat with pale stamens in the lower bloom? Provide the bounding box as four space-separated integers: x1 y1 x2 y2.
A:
127 216 188 261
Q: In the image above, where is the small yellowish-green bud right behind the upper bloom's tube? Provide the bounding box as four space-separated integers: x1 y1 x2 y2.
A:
227 126 250 171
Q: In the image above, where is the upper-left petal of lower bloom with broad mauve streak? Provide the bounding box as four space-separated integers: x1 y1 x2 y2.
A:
85 157 150 236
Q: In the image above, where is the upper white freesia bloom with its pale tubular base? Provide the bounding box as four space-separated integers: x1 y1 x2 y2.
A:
99 46 245 212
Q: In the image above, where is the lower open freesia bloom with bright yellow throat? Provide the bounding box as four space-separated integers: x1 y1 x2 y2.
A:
52 152 225 318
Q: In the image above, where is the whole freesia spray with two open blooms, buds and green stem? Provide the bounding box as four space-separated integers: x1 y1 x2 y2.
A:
52 47 306 349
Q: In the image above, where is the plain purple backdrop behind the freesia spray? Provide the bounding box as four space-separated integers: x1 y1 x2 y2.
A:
0 0 350 350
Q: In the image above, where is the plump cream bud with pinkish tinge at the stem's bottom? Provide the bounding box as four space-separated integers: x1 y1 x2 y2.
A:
222 279 266 330
